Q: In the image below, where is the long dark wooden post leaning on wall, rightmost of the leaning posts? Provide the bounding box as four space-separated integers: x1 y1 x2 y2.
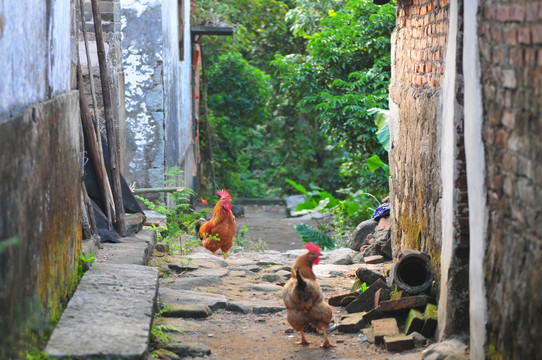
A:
90 0 126 237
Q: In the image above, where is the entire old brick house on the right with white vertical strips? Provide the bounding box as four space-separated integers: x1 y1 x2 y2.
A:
390 0 542 359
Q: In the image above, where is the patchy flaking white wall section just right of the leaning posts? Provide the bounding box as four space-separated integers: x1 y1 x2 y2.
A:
120 0 165 187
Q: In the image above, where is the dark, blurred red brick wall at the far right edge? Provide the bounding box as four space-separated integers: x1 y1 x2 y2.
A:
478 0 542 359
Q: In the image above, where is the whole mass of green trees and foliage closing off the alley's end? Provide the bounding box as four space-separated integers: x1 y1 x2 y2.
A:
196 0 395 207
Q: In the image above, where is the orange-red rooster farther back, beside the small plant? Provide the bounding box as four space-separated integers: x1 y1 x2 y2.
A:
196 189 235 259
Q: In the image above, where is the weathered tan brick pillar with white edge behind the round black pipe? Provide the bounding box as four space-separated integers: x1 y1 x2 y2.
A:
390 0 469 338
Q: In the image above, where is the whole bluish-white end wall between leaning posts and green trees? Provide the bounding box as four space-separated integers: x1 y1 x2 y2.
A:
121 0 192 193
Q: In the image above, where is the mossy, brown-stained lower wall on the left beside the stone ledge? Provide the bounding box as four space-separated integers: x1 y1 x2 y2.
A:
0 91 82 358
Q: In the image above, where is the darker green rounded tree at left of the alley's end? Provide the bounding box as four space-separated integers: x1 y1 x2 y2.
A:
203 53 271 197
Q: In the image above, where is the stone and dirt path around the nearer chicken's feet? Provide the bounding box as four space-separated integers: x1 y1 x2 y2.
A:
149 248 398 360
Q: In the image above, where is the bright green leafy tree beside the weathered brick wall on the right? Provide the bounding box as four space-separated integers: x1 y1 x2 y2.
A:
273 0 395 197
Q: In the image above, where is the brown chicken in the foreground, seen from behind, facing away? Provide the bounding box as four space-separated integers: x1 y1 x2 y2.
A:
282 244 335 348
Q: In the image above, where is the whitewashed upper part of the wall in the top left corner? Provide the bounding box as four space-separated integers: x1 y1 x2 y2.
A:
0 0 71 118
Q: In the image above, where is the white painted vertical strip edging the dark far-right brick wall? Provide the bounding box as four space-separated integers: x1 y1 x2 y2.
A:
463 0 487 360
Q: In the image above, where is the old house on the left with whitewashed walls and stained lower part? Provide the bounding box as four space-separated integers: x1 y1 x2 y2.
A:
0 0 195 358
